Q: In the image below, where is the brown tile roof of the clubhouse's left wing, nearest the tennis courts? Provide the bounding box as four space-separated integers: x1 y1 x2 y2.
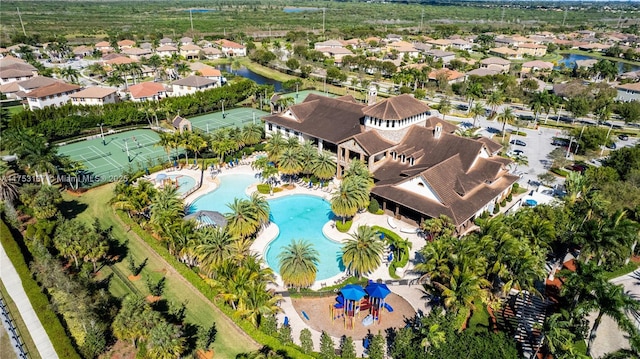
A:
264 94 365 144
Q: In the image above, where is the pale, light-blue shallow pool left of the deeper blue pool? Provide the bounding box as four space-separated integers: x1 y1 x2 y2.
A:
189 174 258 213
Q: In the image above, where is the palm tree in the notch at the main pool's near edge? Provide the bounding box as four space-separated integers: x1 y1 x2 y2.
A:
278 240 319 290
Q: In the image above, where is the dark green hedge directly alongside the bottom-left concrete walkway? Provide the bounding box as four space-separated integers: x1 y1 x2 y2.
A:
0 221 80 359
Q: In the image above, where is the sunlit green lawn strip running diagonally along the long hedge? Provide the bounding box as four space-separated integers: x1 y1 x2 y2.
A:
64 184 257 358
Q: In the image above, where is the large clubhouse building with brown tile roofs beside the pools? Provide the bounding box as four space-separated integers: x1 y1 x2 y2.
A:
264 88 518 233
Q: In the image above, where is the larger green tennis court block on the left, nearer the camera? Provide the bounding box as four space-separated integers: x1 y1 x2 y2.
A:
58 130 175 181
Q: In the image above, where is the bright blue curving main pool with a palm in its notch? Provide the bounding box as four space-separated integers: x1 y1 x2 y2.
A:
264 194 344 281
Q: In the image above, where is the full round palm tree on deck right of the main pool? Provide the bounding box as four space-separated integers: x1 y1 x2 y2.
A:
342 226 384 278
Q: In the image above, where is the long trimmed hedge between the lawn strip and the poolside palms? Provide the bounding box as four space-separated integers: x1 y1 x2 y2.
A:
116 211 314 359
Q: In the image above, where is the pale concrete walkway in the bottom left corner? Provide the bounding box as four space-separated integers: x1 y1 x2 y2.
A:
0 245 58 359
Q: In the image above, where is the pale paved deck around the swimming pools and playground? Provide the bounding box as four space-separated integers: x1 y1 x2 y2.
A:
158 156 430 356
